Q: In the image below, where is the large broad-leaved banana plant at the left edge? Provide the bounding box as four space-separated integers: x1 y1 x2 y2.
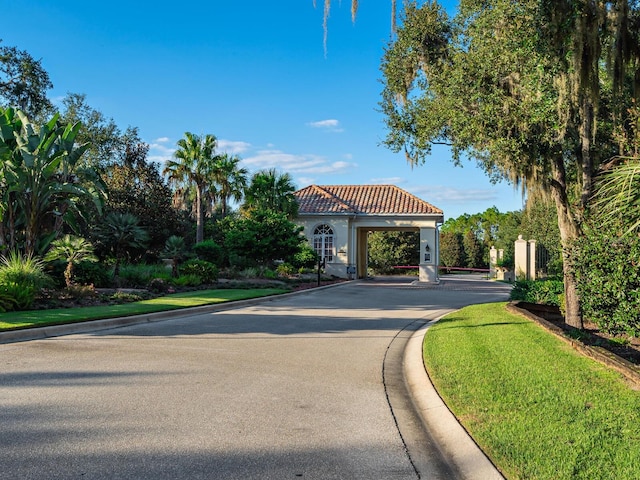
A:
0 111 106 255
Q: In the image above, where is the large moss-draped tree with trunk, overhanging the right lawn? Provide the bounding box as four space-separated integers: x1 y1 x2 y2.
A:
381 0 640 327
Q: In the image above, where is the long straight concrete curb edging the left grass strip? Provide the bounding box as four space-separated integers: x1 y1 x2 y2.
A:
0 280 357 344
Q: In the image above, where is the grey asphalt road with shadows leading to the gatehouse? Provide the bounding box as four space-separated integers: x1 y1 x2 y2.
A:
0 278 507 480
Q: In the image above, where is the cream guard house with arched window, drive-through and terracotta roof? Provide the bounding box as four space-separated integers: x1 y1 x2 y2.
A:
294 185 444 283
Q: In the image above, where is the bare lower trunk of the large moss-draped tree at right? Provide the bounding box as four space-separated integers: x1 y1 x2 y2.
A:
551 155 584 329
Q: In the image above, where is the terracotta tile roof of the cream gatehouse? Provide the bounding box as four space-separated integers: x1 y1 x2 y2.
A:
294 185 442 215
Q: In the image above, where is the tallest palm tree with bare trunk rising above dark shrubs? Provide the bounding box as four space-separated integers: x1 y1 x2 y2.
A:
163 132 218 243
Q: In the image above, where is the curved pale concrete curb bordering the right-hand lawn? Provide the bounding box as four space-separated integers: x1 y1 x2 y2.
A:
403 319 504 480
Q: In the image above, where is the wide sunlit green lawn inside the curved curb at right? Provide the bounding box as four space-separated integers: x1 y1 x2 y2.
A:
424 304 640 480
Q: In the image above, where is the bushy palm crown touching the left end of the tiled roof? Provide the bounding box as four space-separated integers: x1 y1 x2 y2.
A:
243 168 298 218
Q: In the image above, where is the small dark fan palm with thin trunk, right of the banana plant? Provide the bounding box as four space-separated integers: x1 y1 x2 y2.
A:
98 213 149 284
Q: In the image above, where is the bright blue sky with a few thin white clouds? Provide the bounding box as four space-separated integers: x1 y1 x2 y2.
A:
0 0 522 218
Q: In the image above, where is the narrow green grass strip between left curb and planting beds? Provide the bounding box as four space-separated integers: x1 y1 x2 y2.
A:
0 288 288 331
